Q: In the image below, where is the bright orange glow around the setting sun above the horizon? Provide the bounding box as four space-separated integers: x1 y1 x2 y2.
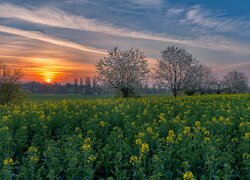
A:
8 56 100 84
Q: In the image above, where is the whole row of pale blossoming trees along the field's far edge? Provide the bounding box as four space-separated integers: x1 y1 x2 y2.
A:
96 46 249 98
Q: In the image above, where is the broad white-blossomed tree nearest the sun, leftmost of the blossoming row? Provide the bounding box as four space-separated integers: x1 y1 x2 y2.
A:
96 48 149 98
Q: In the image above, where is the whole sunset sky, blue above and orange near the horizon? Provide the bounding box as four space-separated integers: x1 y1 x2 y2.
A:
0 0 250 83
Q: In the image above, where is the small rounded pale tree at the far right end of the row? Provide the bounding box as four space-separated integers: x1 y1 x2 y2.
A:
224 71 248 93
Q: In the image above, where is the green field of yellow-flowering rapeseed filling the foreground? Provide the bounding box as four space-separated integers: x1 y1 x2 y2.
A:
0 95 250 179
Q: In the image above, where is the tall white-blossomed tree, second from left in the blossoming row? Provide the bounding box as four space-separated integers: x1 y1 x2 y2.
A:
155 46 198 96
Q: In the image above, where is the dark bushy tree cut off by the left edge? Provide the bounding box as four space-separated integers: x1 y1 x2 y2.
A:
0 63 23 104
